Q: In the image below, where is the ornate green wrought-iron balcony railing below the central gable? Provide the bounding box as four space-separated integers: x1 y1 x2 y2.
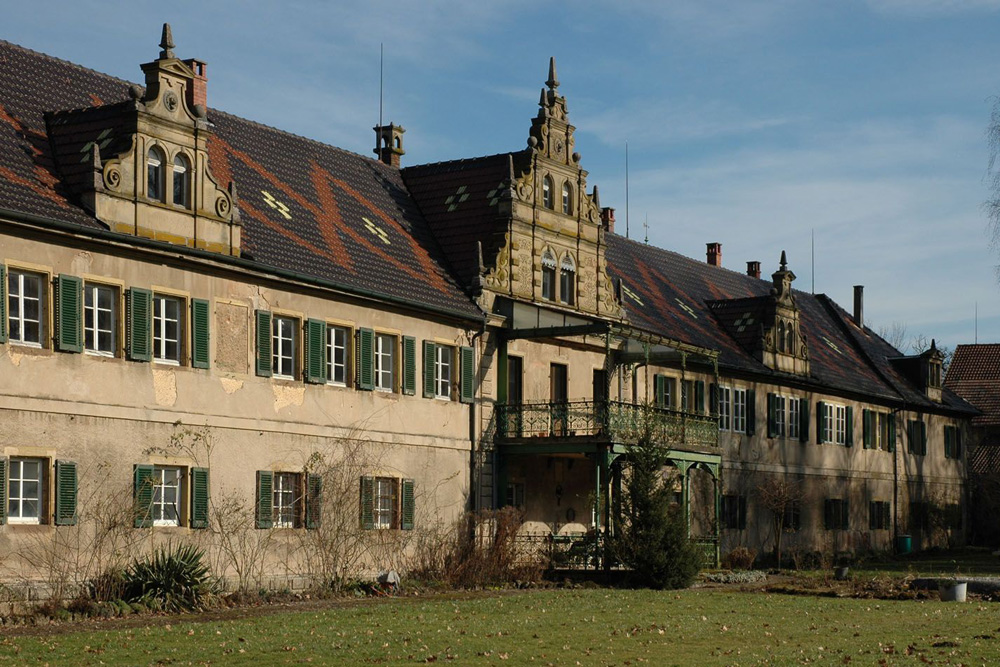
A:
496 401 719 448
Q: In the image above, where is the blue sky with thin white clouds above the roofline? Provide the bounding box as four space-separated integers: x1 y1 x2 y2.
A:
7 0 1000 346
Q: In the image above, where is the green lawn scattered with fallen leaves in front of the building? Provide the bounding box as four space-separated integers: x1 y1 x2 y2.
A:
0 589 1000 665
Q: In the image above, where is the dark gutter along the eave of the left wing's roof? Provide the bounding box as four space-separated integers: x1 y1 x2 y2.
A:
0 207 485 322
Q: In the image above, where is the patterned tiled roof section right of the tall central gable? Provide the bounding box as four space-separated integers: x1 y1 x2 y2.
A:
605 234 969 412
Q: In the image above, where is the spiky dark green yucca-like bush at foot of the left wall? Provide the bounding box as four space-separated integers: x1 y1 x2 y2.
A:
122 545 213 612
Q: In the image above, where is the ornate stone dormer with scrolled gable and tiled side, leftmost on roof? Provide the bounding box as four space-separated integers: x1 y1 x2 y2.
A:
47 24 241 255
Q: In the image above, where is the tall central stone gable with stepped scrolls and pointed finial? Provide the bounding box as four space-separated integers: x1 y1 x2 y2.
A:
484 59 623 318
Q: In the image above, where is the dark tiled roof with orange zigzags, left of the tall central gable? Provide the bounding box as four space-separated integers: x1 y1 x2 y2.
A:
0 41 480 319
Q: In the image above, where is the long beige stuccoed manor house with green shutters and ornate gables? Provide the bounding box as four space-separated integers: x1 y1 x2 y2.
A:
0 27 975 582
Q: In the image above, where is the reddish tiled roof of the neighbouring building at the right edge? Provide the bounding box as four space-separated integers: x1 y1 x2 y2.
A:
944 343 1000 426
